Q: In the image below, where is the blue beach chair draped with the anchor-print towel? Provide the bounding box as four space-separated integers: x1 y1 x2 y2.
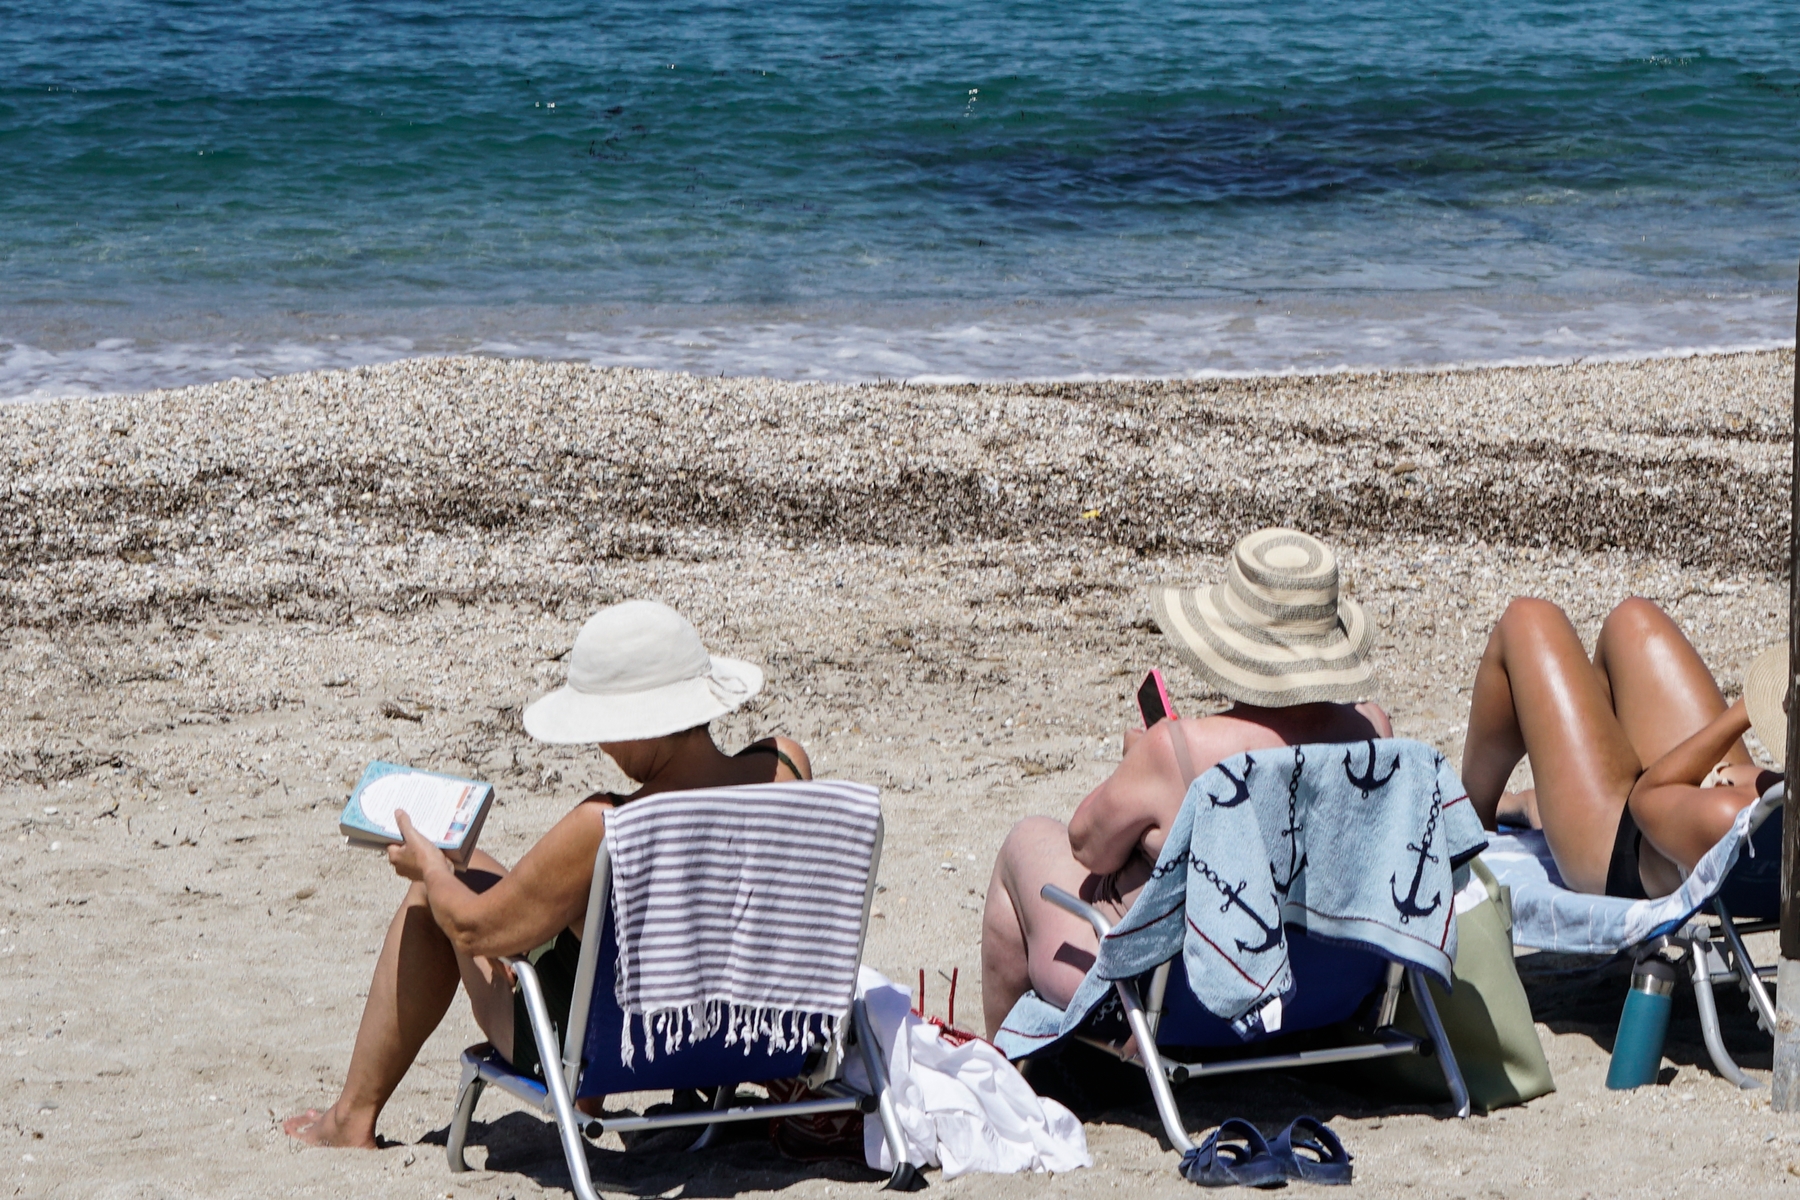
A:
995 739 1481 1153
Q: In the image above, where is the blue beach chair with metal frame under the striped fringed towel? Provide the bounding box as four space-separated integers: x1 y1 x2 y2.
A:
446 783 925 1200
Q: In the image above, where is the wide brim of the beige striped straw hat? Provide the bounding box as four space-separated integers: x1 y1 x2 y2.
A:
1150 585 1375 709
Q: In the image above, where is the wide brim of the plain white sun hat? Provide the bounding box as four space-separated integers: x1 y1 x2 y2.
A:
524 655 763 745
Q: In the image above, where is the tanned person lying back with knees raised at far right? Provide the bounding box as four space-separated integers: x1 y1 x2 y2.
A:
1462 597 1787 900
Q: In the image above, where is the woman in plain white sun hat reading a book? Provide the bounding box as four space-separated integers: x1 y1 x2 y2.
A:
283 601 812 1148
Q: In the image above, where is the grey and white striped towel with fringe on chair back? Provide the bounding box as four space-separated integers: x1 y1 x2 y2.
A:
607 781 880 1067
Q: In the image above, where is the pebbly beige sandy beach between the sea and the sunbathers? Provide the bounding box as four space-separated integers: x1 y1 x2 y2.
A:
0 341 1800 1200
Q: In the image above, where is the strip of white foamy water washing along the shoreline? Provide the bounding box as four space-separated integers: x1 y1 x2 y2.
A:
0 293 1795 401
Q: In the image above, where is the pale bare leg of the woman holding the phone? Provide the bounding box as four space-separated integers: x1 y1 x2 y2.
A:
981 817 1120 1036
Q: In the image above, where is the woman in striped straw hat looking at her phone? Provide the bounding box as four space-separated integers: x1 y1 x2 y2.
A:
981 529 1393 1036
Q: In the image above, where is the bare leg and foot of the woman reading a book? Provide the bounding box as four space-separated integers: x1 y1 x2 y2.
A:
281 855 513 1150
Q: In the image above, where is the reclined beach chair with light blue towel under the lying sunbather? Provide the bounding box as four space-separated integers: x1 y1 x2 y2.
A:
1481 783 1787 1088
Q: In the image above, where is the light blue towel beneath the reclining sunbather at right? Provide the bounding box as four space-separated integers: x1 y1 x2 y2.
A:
1481 784 1787 954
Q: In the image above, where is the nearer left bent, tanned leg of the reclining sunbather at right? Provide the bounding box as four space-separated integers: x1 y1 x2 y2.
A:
1462 599 1643 892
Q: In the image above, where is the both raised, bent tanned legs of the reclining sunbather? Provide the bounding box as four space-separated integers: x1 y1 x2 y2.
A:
1462 597 1750 892
